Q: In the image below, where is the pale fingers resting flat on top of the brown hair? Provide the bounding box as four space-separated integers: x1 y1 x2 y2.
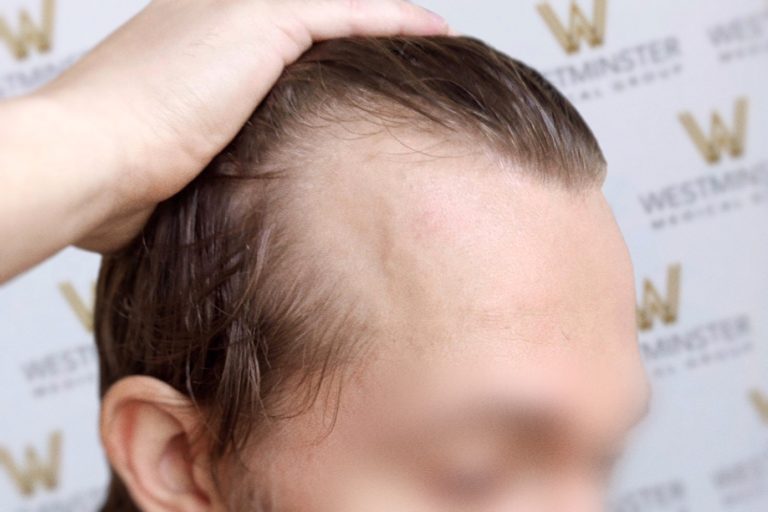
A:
281 0 449 41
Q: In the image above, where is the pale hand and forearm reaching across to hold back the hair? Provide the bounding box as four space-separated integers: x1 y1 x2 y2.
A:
0 0 448 283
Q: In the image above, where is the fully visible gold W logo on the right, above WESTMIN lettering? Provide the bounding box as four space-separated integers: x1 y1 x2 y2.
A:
680 98 748 164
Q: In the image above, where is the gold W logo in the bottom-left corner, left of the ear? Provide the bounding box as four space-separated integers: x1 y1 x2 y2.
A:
0 431 61 496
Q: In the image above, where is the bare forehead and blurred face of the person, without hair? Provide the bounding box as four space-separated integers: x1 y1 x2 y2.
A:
231 133 647 512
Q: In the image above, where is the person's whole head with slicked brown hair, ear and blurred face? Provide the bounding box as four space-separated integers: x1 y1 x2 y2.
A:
96 37 647 512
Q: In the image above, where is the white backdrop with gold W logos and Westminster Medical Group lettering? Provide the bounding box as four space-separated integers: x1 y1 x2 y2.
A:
0 0 768 512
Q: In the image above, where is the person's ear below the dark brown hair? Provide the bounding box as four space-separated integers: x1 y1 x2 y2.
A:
100 376 225 512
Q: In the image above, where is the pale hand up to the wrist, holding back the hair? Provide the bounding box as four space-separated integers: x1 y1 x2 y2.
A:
37 0 448 252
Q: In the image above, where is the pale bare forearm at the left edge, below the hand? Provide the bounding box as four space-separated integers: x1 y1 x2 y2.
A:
0 95 115 283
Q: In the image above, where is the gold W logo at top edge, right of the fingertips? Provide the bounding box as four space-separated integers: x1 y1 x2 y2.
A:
536 0 608 54
